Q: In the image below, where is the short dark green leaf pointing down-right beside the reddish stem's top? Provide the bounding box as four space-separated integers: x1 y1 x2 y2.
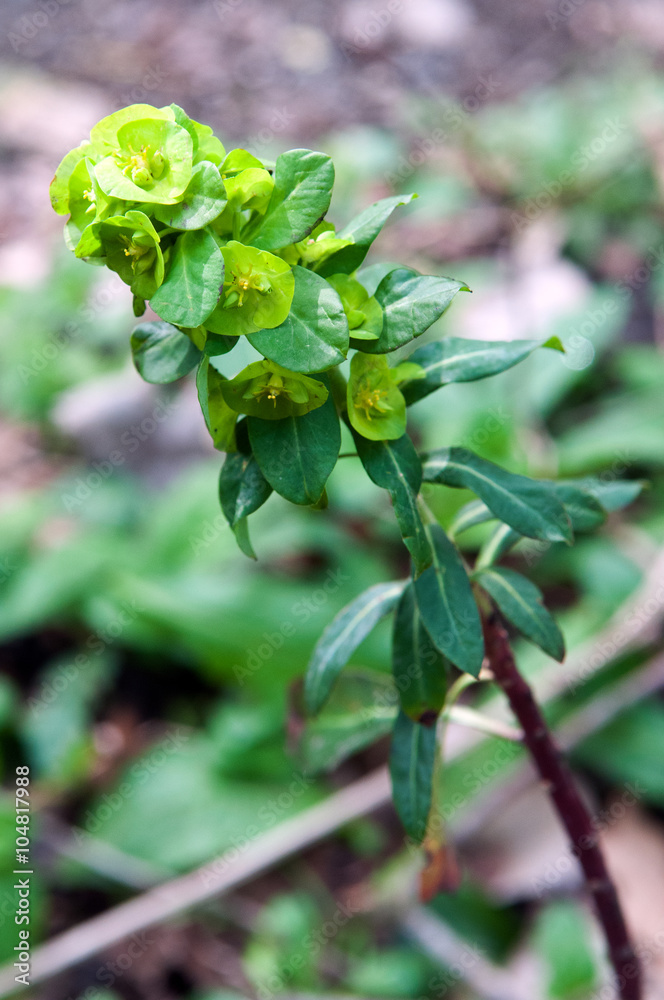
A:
474 566 565 663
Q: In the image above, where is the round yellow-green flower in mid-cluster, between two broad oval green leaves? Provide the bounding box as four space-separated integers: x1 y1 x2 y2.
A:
205 240 295 336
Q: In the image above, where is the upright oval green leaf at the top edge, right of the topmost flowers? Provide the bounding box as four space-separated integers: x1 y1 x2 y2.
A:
252 149 334 250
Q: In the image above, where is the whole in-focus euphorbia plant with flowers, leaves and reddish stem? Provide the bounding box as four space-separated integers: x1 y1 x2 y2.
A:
51 105 640 1000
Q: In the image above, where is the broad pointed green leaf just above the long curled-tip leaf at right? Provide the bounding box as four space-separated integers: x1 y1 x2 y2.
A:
361 267 467 354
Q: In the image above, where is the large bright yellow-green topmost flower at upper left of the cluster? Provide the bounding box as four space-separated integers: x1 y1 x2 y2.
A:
91 104 194 205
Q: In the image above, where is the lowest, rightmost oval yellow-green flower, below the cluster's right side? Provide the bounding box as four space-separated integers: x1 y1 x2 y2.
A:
346 351 407 441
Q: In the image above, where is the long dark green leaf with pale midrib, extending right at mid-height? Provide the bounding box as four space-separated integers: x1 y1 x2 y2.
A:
423 448 573 542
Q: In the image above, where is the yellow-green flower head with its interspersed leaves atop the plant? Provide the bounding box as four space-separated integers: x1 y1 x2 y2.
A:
51 104 452 440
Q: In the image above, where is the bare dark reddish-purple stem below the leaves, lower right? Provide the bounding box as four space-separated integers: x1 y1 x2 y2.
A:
484 612 641 1000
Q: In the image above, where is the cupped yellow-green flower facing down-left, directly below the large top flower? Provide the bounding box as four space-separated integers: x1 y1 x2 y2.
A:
81 211 164 299
